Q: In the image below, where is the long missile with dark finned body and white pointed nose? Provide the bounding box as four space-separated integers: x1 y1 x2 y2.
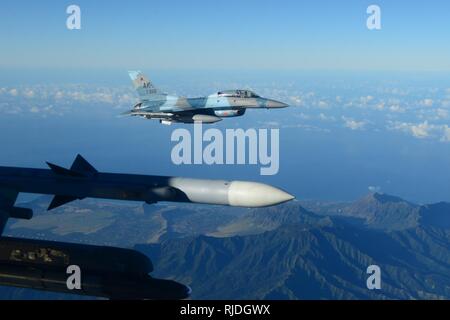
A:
0 155 294 211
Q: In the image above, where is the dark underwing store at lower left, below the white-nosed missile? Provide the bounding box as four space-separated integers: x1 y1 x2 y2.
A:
0 237 191 300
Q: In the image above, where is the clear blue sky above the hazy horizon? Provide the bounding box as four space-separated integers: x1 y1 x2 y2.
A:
0 0 450 71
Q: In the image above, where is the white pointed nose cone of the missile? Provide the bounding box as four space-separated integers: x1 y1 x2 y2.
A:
228 181 295 208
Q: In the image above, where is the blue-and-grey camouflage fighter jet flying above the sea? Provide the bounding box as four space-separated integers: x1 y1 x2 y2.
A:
124 71 288 125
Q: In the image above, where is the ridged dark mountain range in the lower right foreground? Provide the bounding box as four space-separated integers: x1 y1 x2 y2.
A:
136 222 450 299
